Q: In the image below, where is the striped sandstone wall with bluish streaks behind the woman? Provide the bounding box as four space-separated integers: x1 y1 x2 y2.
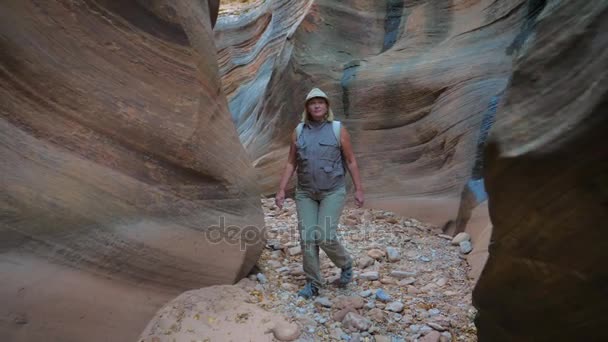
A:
216 0 528 224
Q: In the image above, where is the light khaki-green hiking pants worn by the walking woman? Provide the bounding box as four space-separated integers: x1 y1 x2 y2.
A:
295 186 352 287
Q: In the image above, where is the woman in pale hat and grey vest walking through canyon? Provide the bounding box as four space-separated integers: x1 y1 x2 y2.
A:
275 88 364 298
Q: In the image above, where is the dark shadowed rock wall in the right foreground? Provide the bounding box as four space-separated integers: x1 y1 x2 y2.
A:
473 0 608 342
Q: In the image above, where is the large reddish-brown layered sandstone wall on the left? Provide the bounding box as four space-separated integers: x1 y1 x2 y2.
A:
0 0 263 341
